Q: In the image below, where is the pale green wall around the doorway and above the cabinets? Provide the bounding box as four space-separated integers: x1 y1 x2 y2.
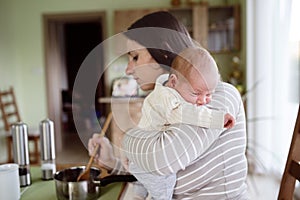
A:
0 0 245 126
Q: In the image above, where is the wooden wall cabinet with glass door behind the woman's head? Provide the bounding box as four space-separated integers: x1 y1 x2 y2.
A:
114 4 241 53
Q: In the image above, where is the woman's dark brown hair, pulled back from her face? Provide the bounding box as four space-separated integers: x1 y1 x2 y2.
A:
124 11 195 70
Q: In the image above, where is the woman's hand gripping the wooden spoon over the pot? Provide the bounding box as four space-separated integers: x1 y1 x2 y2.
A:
88 133 116 171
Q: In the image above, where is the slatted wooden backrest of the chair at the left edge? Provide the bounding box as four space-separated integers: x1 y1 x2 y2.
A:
0 87 21 131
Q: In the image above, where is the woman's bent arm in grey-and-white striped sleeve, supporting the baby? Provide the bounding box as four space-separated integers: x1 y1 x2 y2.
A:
123 83 241 175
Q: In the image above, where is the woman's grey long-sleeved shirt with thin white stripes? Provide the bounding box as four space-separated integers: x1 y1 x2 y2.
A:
119 82 249 200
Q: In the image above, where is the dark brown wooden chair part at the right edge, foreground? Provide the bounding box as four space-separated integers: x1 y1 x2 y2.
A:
278 106 300 200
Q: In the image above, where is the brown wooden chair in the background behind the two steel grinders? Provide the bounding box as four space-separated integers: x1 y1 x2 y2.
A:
0 87 40 164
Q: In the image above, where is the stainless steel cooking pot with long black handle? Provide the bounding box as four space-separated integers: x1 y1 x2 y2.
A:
54 166 136 200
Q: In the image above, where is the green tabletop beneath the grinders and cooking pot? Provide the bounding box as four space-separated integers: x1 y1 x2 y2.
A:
20 166 124 200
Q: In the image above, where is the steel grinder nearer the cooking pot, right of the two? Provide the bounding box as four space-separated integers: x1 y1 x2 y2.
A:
40 119 56 180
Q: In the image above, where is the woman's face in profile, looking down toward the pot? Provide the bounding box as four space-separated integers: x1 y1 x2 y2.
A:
126 40 166 91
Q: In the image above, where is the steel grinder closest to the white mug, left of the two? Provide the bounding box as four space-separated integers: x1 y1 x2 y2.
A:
11 122 31 187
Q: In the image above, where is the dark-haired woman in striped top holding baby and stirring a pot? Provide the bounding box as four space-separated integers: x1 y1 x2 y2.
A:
89 12 249 200
